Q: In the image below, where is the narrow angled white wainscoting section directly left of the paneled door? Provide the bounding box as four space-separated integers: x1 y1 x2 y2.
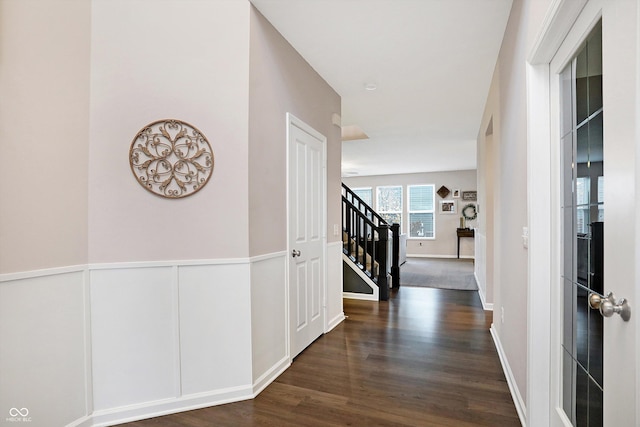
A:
251 252 289 393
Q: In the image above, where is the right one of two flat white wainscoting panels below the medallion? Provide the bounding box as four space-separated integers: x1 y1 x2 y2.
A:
178 264 254 395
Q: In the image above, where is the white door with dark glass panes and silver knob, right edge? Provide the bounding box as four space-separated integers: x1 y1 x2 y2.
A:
550 0 640 426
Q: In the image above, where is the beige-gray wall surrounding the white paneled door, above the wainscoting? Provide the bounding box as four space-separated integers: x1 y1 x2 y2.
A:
249 7 342 256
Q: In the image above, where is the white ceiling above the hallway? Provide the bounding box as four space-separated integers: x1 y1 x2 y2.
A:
251 0 512 176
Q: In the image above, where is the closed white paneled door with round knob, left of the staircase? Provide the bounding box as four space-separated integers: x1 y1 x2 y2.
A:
287 114 326 358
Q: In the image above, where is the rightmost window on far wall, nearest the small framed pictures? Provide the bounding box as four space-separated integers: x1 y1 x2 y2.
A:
407 184 435 238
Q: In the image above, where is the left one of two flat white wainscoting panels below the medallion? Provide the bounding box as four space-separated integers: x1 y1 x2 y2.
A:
91 267 180 411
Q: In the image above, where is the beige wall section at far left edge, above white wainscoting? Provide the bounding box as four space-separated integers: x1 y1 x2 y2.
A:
0 0 90 274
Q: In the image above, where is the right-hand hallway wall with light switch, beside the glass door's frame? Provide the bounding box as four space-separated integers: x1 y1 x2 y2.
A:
478 0 551 401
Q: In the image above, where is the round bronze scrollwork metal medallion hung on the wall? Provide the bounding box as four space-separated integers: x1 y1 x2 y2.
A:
129 119 213 199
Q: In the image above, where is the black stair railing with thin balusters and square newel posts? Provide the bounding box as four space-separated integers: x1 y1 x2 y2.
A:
342 184 400 301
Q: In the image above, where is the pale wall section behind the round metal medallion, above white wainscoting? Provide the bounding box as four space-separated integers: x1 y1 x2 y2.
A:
89 0 250 263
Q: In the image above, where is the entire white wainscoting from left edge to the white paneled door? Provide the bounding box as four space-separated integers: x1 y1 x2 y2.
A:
0 252 302 427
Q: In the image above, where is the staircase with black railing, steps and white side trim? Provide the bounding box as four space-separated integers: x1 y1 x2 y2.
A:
342 184 400 301
